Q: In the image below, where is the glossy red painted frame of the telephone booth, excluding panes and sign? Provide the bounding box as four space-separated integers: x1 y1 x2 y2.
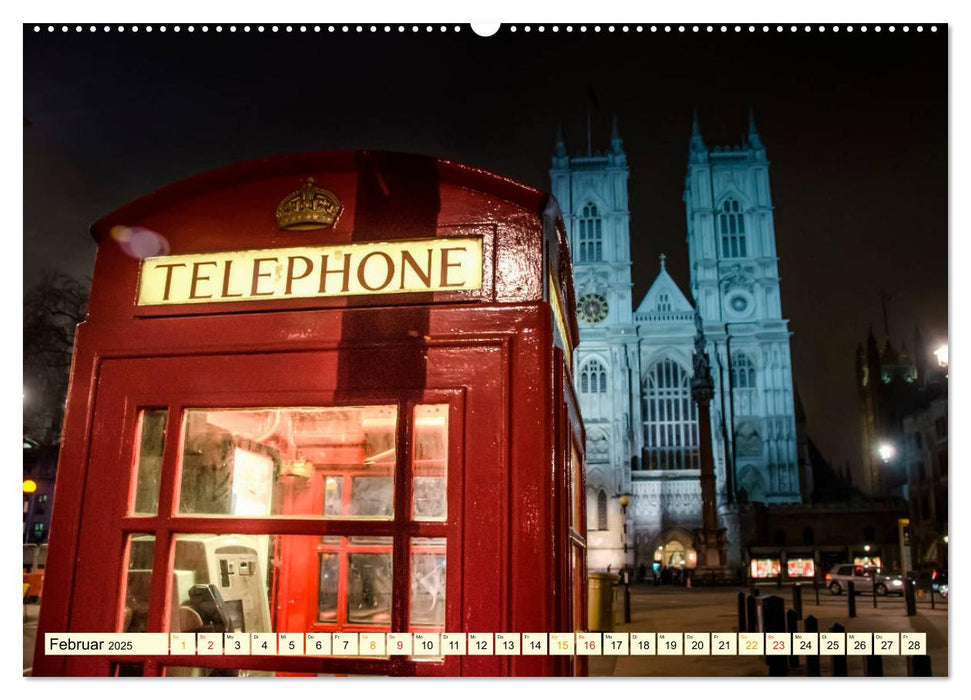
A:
34 152 586 675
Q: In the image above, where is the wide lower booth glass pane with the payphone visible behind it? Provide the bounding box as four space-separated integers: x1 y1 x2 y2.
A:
171 533 392 633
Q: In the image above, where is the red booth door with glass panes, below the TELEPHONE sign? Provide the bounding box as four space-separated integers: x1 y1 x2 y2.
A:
65 347 503 675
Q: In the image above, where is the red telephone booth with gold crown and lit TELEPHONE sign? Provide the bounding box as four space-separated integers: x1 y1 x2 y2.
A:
34 152 586 675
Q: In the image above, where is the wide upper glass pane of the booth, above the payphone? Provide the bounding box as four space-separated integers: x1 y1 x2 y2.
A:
178 406 398 519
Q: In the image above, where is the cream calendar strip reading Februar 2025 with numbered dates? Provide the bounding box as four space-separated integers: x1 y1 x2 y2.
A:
44 632 927 660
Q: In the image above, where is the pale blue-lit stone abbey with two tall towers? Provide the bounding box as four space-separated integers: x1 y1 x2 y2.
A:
550 113 805 571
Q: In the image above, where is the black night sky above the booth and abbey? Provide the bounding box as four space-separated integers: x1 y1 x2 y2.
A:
24 25 948 478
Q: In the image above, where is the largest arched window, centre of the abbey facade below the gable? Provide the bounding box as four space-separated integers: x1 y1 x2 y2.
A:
643 359 700 469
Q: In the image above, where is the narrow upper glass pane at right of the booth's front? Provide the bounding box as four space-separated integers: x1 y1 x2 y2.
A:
412 404 448 520
